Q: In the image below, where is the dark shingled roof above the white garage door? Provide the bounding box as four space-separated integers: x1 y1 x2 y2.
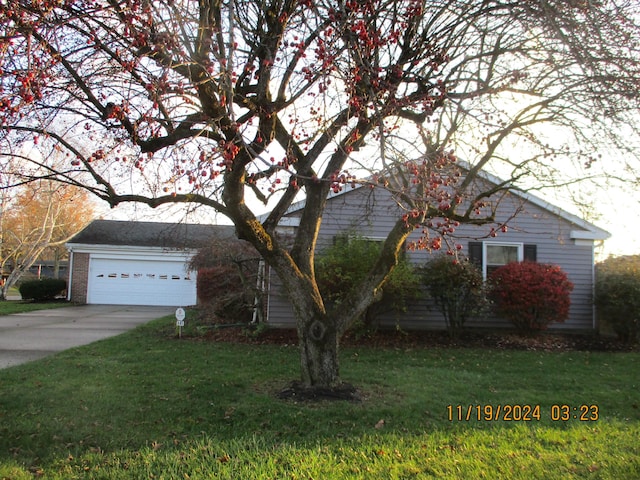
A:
68 220 235 249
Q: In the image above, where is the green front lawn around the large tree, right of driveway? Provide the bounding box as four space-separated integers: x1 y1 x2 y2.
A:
0 317 640 479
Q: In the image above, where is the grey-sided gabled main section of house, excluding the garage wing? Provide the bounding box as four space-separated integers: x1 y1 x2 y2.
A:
267 173 610 331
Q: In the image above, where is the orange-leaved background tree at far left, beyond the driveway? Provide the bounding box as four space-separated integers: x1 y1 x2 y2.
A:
0 180 95 299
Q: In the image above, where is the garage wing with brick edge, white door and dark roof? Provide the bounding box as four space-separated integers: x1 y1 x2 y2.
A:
66 220 235 307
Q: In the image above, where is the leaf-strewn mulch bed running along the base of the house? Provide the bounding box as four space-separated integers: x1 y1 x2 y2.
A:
199 327 640 352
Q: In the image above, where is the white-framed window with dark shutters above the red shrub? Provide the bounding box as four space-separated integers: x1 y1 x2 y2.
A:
469 242 537 279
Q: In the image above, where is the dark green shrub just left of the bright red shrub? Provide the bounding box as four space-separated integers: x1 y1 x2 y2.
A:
420 255 486 337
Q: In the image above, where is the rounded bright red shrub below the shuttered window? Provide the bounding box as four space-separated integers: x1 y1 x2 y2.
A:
489 262 573 333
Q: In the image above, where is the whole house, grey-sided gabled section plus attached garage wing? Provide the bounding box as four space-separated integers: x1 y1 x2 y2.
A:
67 174 610 330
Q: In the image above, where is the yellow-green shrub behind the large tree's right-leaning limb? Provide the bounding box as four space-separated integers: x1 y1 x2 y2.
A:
315 235 420 326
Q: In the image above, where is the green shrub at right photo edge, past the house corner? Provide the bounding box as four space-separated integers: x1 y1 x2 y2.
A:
595 256 640 342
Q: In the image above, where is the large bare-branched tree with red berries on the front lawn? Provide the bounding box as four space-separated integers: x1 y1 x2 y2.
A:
0 0 640 387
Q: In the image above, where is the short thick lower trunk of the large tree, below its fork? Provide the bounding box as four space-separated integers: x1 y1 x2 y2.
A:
298 314 340 389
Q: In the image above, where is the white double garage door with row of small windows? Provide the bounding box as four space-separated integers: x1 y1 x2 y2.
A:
87 258 196 307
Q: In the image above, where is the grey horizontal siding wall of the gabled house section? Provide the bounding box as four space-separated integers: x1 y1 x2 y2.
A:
268 188 595 330
